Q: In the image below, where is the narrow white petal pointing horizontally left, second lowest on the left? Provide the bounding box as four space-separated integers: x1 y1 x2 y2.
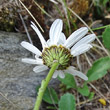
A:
21 58 43 65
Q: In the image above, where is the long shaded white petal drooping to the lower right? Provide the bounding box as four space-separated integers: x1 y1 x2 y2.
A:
68 66 88 80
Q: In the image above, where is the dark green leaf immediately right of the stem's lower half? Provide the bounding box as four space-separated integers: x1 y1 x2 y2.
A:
37 86 58 104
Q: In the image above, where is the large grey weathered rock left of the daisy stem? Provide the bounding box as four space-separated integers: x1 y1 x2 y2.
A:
0 32 58 110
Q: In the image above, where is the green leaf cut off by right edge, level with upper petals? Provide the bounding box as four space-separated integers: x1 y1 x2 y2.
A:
102 26 110 49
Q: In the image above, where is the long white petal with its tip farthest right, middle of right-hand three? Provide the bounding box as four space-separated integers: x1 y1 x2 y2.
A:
72 34 96 49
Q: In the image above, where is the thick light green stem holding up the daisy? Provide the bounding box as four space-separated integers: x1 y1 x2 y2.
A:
34 62 59 110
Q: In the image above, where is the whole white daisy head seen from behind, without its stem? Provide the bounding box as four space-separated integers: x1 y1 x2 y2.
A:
21 19 96 80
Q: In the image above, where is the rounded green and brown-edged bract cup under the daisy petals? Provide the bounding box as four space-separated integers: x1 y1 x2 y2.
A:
42 45 73 70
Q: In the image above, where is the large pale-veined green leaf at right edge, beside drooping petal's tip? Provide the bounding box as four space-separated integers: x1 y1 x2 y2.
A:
87 57 110 82
